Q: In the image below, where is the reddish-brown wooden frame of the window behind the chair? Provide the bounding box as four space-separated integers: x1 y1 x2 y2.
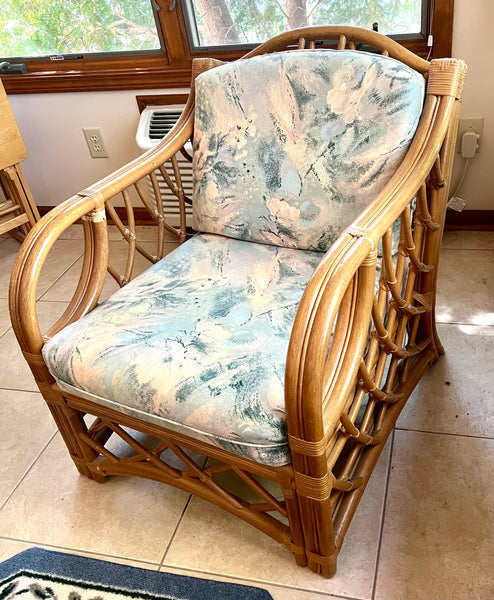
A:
1 0 454 94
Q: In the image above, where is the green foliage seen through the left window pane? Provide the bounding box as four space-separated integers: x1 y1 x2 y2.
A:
0 0 160 58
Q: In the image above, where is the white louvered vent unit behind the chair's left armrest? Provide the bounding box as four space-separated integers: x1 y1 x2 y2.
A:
136 105 192 226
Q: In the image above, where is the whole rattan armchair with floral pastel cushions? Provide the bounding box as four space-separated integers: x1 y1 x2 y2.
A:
10 27 465 577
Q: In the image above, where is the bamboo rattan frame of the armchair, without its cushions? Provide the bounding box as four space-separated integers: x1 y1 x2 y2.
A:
10 27 466 577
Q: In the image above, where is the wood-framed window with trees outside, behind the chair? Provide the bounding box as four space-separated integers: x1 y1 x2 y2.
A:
0 0 454 93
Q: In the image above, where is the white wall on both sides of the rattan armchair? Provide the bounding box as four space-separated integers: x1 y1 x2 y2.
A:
6 0 494 210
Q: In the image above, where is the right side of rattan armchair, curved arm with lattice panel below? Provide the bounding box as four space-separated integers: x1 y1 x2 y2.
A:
285 70 464 570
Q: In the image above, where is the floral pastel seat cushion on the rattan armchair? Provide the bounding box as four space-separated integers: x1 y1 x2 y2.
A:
43 234 321 465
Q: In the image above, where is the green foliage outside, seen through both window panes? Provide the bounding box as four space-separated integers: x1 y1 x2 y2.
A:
0 0 421 58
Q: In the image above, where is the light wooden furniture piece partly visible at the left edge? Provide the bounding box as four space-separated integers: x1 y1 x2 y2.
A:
0 81 40 241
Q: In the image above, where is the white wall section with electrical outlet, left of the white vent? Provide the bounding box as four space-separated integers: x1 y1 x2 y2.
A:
9 90 186 206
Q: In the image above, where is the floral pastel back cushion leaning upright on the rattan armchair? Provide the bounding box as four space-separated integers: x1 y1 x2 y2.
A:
193 50 425 251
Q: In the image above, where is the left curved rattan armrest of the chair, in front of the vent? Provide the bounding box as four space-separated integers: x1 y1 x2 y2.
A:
9 99 193 381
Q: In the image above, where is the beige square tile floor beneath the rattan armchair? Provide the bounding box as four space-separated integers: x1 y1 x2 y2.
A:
0 229 494 600
